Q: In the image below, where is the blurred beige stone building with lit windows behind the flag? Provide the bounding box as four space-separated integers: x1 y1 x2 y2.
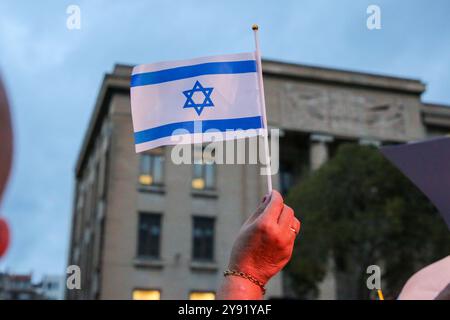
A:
66 60 450 299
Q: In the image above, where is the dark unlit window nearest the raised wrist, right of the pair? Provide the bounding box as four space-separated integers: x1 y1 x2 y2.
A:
192 217 214 261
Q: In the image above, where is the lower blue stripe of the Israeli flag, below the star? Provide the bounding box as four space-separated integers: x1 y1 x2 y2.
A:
134 116 263 144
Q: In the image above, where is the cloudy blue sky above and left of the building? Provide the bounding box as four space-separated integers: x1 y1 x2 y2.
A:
0 0 450 276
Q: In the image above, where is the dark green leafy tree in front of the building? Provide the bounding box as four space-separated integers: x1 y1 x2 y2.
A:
286 144 450 299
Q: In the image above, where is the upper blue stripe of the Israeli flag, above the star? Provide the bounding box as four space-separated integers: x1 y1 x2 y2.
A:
130 60 256 87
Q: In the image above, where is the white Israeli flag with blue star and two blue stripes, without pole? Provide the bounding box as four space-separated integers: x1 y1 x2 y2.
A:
130 52 264 152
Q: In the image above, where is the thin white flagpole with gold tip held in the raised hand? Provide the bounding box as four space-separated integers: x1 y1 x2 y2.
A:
252 24 272 192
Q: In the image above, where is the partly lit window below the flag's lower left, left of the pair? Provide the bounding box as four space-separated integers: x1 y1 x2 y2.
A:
139 148 164 186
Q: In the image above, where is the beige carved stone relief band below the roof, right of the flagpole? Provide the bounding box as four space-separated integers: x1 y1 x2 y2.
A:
265 77 425 141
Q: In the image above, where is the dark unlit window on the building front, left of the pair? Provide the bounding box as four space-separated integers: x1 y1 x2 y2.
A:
138 213 161 258
